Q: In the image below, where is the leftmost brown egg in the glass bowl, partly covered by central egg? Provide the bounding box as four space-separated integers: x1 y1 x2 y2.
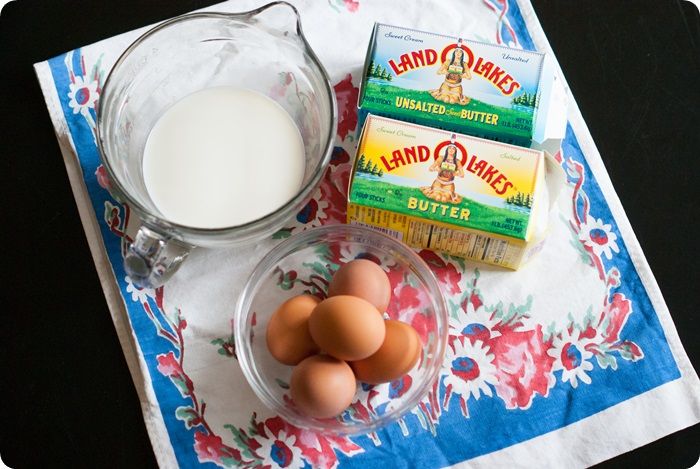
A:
265 295 320 365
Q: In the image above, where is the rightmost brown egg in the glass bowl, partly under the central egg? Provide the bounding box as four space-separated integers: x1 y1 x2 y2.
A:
350 319 421 384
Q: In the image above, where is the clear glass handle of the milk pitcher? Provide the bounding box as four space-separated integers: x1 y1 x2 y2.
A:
124 225 192 288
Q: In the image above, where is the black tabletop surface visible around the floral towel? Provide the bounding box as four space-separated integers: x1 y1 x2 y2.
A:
0 0 700 468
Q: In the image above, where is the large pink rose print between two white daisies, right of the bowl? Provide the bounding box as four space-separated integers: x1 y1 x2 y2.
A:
489 326 554 409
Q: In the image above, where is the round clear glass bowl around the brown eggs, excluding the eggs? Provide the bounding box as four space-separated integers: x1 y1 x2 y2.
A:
234 225 448 435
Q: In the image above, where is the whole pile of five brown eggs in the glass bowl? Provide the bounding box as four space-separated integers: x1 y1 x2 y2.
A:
266 259 421 418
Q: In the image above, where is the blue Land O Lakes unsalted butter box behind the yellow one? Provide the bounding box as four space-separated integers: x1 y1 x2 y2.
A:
358 24 566 151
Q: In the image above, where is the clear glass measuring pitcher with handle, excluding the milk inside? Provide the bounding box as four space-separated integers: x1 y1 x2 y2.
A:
97 1 337 287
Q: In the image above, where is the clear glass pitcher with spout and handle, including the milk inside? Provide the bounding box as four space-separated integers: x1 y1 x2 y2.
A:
97 2 337 287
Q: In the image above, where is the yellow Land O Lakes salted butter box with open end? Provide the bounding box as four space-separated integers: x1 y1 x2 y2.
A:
347 115 549 269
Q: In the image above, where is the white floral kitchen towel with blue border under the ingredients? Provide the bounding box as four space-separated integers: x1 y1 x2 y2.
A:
36 0 700 468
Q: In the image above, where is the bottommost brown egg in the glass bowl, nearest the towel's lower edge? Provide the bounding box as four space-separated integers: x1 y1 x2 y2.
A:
289 355 357 419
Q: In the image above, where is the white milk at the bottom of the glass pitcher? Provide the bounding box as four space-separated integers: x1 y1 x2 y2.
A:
143 87 304 228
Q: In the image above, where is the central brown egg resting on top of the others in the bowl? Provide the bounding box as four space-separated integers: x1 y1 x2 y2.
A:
309 295 385 360
